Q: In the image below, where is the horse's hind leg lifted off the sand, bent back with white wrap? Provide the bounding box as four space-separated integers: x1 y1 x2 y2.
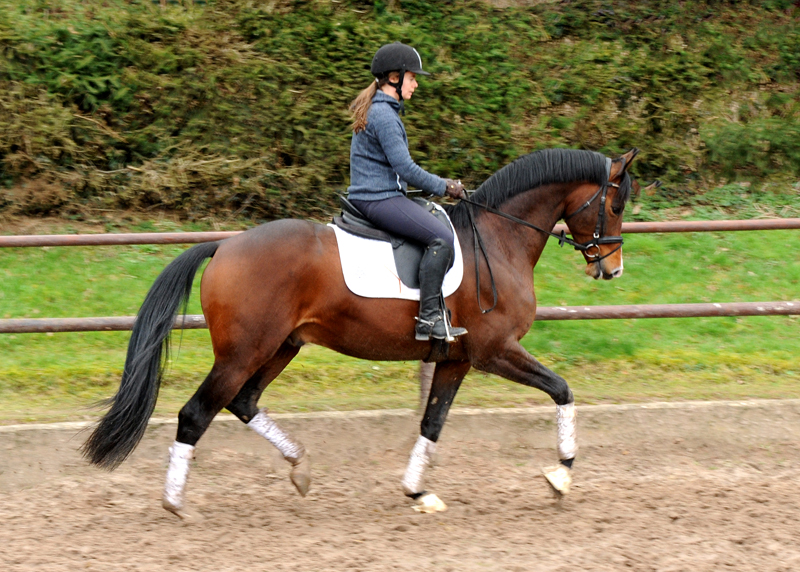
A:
227 342 311 496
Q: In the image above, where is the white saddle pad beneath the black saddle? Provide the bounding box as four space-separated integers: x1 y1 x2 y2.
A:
329 211 464 300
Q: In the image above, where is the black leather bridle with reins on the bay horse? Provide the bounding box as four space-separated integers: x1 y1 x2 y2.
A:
461 157 625 314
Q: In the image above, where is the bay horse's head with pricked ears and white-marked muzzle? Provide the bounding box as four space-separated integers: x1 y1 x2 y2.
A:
564 148 639 280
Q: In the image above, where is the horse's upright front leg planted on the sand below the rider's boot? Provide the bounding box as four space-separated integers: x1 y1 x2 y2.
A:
402 361 471 512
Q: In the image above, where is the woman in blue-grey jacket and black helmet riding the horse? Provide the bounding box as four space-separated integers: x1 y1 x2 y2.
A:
347 42 467 341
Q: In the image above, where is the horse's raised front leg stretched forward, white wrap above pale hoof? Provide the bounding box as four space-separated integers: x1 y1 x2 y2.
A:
476 341 578 494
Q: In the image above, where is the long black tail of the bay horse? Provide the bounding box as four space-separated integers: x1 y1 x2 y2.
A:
82 242 219 470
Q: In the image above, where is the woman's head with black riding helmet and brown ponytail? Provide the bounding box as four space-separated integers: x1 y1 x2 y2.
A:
350 42 431 133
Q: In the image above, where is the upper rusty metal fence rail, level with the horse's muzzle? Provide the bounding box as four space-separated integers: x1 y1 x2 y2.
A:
0 218 800 247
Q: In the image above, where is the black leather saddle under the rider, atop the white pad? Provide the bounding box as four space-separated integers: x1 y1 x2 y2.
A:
333 195 455 288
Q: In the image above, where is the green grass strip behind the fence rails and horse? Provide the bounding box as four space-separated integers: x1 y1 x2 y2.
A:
0 216 800 423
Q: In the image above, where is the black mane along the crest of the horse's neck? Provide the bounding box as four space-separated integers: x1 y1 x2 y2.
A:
446 149 631 228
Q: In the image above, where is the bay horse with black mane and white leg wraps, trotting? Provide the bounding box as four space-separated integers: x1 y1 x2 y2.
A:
82 149 638 517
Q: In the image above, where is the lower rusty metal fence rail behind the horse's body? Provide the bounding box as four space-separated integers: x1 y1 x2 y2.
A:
0 300 800 334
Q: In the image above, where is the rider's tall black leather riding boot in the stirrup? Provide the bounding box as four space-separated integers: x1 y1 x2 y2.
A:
415 238 467 341
